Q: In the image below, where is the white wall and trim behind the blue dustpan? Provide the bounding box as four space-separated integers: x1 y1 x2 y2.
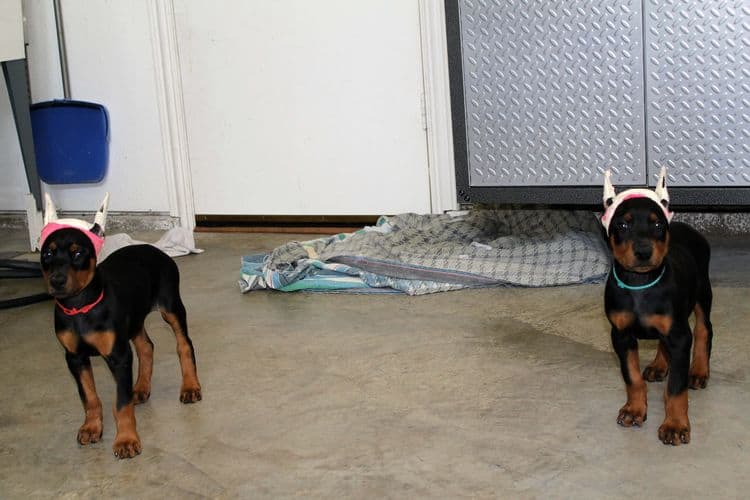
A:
0 0 170 212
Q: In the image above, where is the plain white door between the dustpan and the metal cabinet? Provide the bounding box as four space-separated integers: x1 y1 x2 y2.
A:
174 0 430 215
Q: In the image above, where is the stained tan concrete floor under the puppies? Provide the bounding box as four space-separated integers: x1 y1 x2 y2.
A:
0 230 750 499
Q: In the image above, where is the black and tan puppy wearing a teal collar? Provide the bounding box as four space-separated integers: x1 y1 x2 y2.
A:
602 171 713 445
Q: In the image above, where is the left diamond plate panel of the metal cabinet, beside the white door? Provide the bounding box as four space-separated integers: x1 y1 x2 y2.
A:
459 0 646 186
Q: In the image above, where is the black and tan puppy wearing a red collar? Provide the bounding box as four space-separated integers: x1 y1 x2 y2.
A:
40 193 201 458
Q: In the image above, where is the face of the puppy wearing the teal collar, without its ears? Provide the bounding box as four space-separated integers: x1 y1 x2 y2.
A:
608 198 669 273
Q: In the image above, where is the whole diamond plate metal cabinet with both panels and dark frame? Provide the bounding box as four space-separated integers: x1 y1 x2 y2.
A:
445 0 750 206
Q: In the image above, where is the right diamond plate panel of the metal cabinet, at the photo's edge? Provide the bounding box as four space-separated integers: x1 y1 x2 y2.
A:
645 0 750 187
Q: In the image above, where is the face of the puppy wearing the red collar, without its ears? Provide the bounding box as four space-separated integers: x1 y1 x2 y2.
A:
41 227 96 298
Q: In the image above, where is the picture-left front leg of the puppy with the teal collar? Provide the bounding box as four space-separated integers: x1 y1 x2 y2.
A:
611 326 648 427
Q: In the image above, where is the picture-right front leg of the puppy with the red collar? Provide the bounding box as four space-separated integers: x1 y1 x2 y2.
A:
105 341 141 458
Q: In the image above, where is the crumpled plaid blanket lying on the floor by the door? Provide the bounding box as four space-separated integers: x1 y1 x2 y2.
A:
239 210 609 295
